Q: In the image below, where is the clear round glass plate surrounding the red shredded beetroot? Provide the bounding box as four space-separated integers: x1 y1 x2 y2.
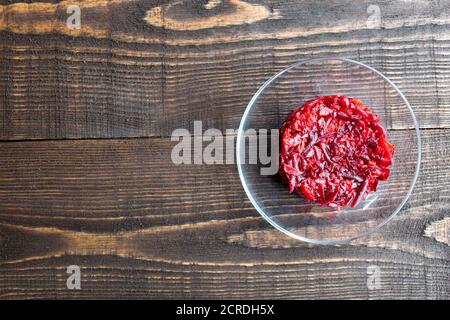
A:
236 58 421 244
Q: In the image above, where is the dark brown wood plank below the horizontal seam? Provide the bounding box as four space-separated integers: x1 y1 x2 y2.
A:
0 129 450 299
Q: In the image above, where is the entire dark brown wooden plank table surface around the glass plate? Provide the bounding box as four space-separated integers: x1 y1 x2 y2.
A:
0 0 450 299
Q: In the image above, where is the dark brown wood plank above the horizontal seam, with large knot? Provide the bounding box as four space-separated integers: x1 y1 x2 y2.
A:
0 0 450 140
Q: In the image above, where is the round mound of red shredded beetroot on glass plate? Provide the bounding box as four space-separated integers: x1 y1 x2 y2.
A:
279 96 394 207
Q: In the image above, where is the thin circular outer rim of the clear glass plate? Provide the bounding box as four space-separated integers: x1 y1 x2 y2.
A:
236 56 422 245
